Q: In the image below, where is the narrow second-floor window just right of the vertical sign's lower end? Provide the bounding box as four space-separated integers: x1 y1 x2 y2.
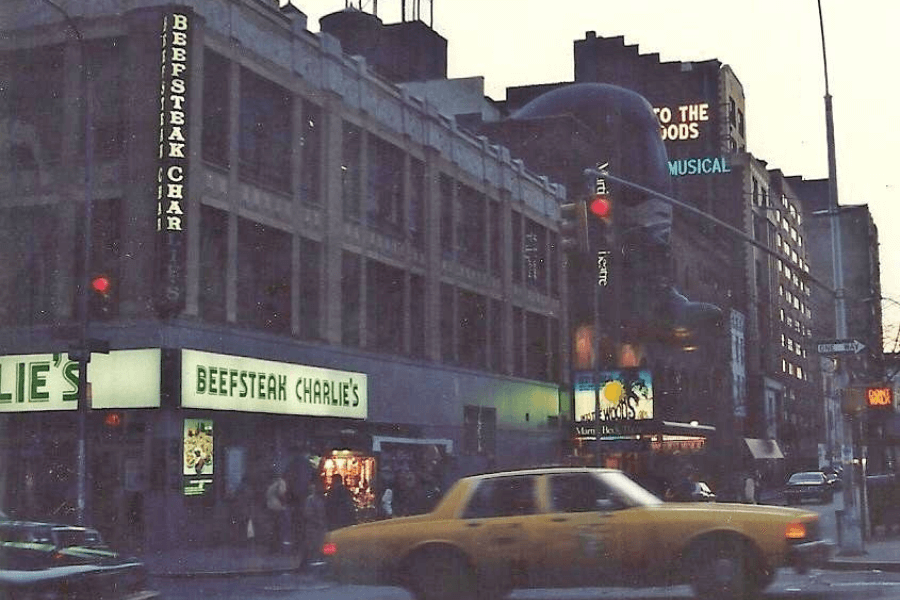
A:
200 205 228 323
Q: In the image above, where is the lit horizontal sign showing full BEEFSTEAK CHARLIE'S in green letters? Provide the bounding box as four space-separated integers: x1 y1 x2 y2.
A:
181 350 368 419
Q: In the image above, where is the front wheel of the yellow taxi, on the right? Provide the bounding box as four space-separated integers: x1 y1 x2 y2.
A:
691 538 765 600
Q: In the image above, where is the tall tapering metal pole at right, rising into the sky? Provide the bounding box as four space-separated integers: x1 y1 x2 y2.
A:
817 0 865 554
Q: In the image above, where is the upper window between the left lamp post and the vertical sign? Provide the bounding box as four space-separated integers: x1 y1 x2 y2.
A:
82 39 125 159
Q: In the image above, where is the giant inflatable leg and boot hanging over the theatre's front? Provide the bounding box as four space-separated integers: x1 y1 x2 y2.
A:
511 83 722 356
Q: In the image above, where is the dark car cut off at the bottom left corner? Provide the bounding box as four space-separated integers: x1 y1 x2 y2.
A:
0 520 159 600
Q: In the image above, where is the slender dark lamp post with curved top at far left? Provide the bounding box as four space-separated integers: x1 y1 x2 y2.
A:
44 0 94 525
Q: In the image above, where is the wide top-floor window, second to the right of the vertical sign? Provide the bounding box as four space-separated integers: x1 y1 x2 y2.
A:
239 69 291 192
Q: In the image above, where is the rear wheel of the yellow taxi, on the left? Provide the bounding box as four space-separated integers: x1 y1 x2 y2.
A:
407 550 477 600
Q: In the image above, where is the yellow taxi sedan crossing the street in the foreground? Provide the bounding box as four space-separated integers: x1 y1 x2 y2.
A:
323 467 831 600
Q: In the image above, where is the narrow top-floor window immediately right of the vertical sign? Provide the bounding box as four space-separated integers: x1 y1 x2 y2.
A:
203 50 231 167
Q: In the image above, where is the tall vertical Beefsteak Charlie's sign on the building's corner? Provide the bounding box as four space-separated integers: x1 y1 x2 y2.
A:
156 11 191 315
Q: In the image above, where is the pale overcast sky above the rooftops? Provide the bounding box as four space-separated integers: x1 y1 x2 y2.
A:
304 0 900 349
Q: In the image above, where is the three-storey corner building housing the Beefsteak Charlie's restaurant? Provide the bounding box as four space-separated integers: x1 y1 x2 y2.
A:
0 0 566 549
